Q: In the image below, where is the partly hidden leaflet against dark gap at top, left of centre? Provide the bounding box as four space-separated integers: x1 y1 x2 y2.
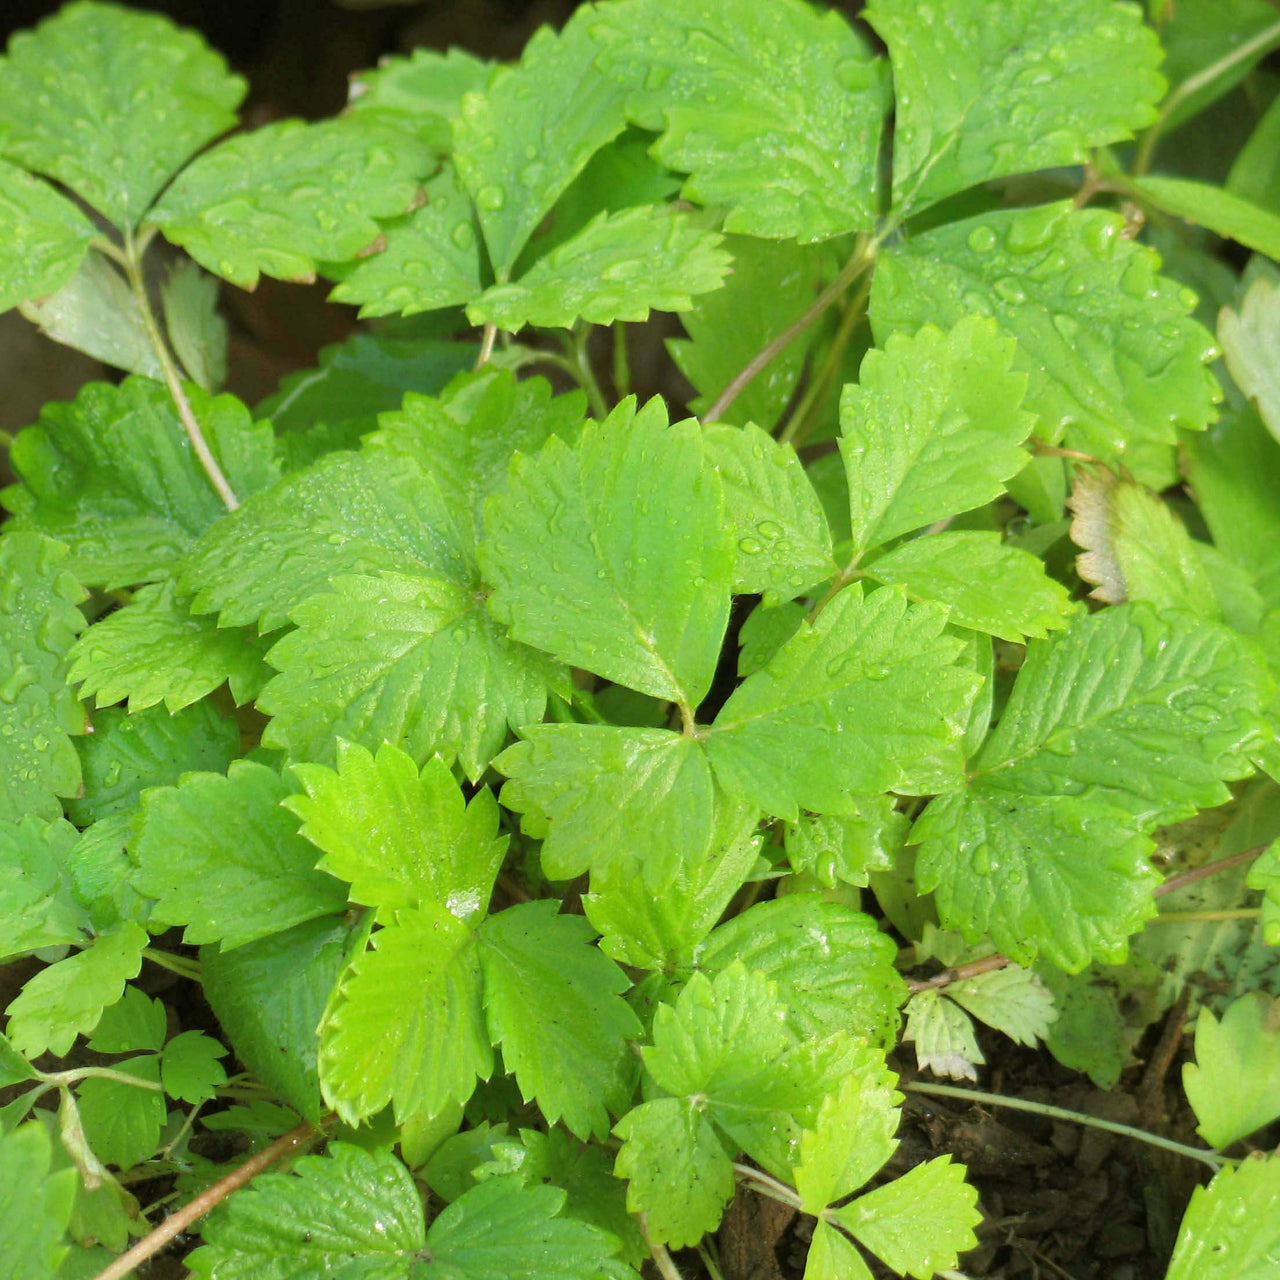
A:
347 49 493 151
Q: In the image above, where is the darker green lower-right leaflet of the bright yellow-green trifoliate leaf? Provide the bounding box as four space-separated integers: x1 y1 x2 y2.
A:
479 902 641 1138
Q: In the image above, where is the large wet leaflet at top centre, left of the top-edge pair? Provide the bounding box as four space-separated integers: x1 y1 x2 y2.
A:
596 0 888 241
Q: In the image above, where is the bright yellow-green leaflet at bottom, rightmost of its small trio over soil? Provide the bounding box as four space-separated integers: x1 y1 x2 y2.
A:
831 1156 982 1280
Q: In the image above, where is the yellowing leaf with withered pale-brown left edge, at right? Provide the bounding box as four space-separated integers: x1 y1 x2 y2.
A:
1071 470 1220 620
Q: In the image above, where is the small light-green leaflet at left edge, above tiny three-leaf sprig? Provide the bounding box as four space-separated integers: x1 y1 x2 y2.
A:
8 920 147 1059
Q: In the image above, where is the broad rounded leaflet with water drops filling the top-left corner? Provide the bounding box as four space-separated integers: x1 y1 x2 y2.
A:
0 3 246 229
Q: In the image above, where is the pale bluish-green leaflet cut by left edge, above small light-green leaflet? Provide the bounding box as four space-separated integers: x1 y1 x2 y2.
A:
0 815 88 959
